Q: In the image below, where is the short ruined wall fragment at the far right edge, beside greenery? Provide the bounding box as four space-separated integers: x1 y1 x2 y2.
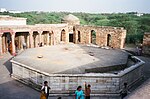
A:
143 33 150 55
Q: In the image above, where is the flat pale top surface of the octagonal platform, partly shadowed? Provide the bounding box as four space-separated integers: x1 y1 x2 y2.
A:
13 44 128 74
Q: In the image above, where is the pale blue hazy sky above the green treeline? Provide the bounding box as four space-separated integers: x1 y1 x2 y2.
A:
0 0 150 13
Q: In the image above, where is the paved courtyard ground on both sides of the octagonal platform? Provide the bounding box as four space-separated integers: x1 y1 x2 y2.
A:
0 45 150 99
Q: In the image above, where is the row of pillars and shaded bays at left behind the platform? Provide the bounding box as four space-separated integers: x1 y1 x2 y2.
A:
0 31 55 55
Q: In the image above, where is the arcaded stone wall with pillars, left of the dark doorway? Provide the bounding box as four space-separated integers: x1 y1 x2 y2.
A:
0 24 69 55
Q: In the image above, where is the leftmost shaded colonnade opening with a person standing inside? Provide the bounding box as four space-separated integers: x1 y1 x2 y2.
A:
2 32 12 54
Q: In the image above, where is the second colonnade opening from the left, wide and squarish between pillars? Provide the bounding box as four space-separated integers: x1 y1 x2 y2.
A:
15 32 29 52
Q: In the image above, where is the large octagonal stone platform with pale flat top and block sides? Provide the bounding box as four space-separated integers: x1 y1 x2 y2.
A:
11 44 144 99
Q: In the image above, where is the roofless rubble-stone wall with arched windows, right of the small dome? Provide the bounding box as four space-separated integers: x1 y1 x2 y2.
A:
74 25 126 49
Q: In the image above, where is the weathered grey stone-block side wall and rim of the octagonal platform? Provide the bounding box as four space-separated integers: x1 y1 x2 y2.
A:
11 57 144 96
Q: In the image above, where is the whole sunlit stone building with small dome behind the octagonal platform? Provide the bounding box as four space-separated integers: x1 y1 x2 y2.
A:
0 14 126 55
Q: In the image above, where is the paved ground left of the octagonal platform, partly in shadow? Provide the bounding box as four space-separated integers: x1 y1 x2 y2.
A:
0 54 39 99
